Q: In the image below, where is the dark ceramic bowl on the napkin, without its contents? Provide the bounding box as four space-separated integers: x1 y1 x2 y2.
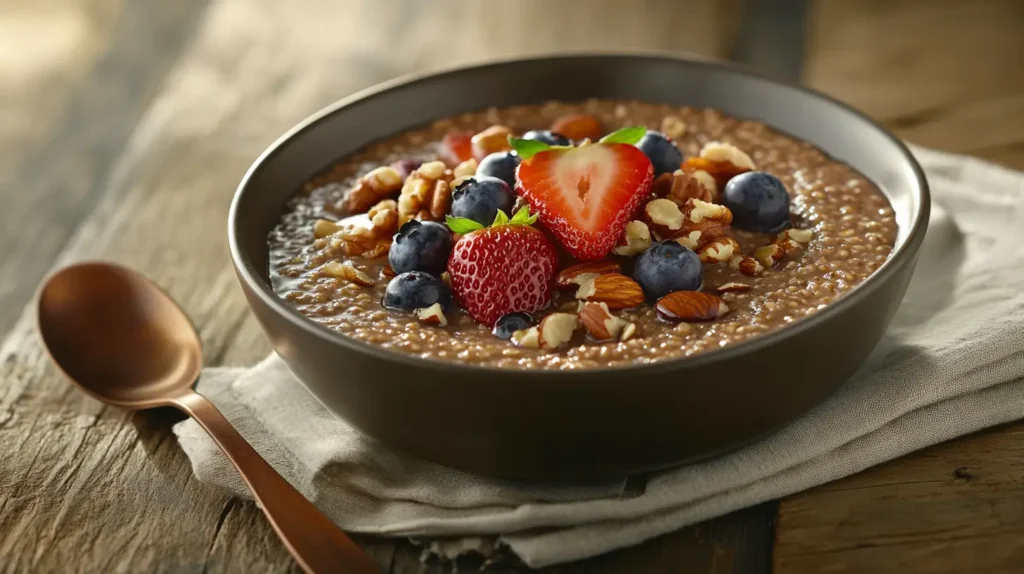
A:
228 54 929 479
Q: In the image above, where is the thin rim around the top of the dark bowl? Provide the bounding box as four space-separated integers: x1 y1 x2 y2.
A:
227 50 931 379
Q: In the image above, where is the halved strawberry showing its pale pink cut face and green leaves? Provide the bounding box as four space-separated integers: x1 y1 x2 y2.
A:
511 127 654 261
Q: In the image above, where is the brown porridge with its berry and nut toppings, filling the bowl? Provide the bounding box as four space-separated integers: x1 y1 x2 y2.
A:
268 100 897 368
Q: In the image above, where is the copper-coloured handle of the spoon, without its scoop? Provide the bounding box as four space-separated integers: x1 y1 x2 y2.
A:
172 392 380 574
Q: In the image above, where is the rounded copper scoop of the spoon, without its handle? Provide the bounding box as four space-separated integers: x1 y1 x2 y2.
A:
39 263 203 409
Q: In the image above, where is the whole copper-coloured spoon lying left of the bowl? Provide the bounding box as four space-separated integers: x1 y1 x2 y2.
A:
39 263 380 574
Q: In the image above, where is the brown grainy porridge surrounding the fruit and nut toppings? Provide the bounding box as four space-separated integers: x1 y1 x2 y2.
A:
268 100 897 368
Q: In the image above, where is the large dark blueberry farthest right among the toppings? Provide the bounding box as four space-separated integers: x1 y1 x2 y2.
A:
722 172 790 233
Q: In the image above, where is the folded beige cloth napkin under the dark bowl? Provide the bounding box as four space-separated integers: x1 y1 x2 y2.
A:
175 148 1024 567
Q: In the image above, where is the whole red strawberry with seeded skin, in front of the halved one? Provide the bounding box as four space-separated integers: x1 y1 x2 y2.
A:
447 207 558 327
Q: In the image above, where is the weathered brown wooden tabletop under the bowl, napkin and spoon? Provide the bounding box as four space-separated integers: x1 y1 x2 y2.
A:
6 0 1024 574
